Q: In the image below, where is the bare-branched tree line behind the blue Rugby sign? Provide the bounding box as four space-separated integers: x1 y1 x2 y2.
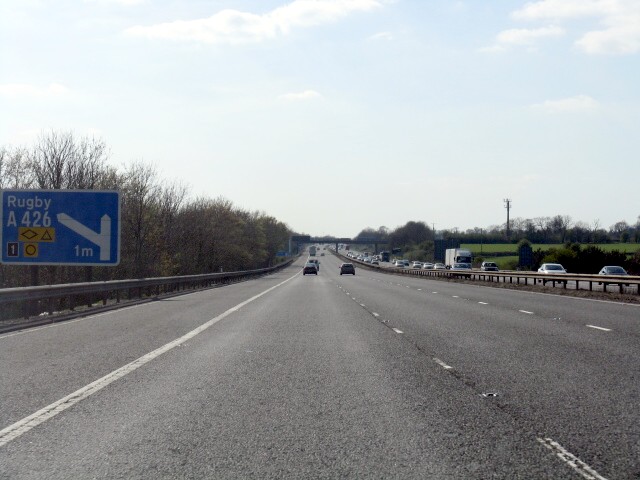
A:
0 131 291 288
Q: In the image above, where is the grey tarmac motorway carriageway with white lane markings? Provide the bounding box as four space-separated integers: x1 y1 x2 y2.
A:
0 250 640 479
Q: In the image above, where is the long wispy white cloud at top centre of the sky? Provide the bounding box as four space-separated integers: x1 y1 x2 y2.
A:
125 0 382 45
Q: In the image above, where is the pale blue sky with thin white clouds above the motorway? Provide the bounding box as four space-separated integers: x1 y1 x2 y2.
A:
0 0 640 237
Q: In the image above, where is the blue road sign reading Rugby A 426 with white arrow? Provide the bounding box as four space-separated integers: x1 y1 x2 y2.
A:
0 190 120 266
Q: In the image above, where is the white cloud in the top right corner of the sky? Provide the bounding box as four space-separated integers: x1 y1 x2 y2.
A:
512 0 640 54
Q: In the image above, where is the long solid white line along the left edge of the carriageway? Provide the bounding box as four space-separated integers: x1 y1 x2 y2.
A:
0 273 299 447
